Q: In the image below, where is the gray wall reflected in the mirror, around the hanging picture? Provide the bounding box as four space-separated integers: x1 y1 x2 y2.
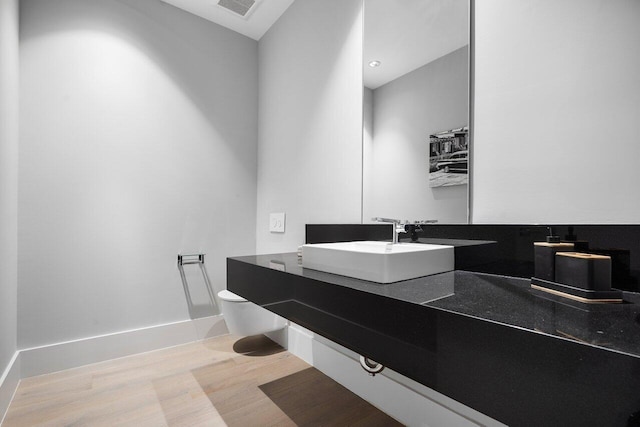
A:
363 47 469 224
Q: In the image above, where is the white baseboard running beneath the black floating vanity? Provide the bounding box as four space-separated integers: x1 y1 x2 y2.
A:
288 325 504 427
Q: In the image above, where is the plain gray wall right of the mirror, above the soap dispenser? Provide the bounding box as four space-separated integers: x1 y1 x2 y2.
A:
472 0 640 224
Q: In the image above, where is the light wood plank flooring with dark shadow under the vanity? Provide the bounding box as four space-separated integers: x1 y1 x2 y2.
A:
2 335 400 427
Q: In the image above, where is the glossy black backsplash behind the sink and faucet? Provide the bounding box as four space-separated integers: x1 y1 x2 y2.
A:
305 224 640 292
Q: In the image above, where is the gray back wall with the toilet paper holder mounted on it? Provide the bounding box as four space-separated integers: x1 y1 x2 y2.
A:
18 0 258 348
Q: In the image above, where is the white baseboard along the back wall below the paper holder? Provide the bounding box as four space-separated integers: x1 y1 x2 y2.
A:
20 315 228 378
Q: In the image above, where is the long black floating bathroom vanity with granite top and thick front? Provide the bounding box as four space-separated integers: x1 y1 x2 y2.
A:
227 249 640 426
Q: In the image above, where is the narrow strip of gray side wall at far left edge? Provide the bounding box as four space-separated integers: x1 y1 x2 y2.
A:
0 0 19 388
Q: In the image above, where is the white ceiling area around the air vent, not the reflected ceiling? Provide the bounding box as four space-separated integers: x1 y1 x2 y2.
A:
161 0 294 40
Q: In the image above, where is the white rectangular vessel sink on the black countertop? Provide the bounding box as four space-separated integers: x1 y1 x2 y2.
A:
302 241 454 283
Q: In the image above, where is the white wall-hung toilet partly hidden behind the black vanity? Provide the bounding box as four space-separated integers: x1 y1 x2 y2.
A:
218 289 287 336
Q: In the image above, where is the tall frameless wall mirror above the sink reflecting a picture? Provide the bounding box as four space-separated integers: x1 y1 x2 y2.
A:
362 0 470 224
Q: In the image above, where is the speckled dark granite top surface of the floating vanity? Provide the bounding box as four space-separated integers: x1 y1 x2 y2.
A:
233 253 640 358
